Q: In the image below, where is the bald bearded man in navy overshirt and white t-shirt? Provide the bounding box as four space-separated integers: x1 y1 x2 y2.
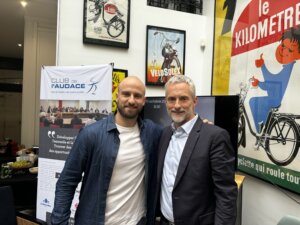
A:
51 76 161 225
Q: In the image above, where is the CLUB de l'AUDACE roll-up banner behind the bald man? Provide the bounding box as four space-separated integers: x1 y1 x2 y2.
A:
36 64 113 224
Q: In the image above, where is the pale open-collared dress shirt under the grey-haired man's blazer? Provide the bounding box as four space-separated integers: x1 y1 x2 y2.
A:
160 115 198 222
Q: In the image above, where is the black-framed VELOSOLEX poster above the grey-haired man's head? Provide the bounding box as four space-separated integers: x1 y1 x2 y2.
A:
146 25 185 86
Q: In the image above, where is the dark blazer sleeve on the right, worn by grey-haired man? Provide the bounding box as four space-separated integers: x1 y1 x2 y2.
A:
210 130 237 225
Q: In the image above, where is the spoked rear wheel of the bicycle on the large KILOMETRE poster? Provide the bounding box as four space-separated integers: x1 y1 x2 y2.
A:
265 118 299 166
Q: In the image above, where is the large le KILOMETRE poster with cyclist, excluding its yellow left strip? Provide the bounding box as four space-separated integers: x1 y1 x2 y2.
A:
218 0 300 193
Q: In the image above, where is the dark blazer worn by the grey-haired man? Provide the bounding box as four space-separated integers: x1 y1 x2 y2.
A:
155 118 237 225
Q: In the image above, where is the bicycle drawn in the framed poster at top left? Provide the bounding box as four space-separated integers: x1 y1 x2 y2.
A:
88 0 125 38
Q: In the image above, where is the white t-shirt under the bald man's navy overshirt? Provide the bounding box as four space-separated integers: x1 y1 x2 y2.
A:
105 124 146 225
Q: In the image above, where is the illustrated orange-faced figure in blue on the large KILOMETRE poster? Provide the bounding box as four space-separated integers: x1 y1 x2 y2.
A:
249 26 300 132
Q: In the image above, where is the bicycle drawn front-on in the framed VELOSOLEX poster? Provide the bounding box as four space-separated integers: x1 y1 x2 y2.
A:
154 31 182 83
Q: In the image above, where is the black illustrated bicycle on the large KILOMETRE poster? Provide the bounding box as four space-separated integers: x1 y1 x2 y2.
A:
238 78 300 166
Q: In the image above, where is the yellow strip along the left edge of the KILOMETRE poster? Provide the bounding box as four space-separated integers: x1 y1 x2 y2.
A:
212 0 232 95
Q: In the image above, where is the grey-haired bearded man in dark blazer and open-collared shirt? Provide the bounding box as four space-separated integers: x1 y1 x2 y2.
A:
155 75 237 225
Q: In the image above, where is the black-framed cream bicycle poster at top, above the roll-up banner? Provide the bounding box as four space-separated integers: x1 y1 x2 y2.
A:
83 0 130 48
